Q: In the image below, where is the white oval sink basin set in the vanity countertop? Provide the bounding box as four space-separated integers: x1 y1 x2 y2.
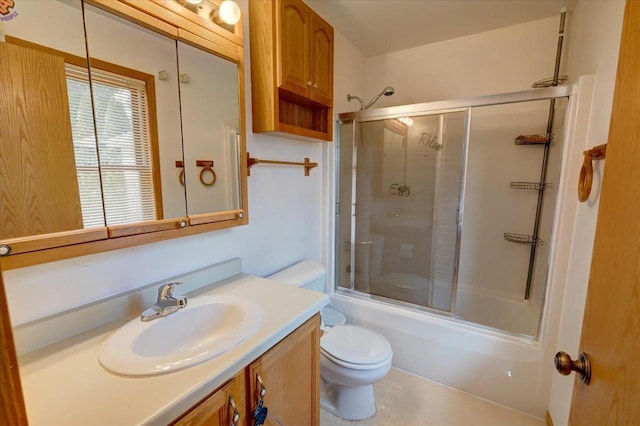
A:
98 296 263 376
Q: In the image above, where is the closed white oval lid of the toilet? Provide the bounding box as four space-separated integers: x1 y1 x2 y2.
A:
320 324 393 365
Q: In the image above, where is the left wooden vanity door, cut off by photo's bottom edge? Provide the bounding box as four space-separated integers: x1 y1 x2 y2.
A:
173 370 249 426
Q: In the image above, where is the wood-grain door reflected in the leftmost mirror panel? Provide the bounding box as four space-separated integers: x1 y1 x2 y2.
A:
0 43 83 239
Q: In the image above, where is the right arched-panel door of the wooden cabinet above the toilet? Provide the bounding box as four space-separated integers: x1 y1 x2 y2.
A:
309 12 333 107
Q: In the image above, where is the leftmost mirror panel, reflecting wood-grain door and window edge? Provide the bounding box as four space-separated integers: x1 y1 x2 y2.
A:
0 0 104 240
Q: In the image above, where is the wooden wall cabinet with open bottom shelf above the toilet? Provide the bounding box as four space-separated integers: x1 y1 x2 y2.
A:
249 0 333 141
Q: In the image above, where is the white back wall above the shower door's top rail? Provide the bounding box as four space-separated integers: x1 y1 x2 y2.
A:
364 17 559 107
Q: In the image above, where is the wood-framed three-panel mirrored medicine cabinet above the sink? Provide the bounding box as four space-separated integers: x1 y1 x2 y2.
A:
0 0 248 269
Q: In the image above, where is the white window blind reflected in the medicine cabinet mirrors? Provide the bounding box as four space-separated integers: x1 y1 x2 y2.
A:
67 65 156 227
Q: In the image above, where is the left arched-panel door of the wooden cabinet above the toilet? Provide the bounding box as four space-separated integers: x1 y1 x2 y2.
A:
278 0 311 97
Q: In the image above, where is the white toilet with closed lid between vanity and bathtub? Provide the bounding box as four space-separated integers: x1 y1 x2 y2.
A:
267 260 393 420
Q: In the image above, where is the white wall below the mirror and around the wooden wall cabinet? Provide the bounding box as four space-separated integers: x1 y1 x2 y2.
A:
3 1 340 325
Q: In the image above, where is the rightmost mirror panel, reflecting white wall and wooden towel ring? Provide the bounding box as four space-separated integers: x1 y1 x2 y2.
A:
178 42 242 215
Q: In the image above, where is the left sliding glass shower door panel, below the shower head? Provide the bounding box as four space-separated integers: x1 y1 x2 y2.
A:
336 111 466 311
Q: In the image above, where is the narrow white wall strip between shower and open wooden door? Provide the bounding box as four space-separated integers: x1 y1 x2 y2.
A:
547 0 624 425
